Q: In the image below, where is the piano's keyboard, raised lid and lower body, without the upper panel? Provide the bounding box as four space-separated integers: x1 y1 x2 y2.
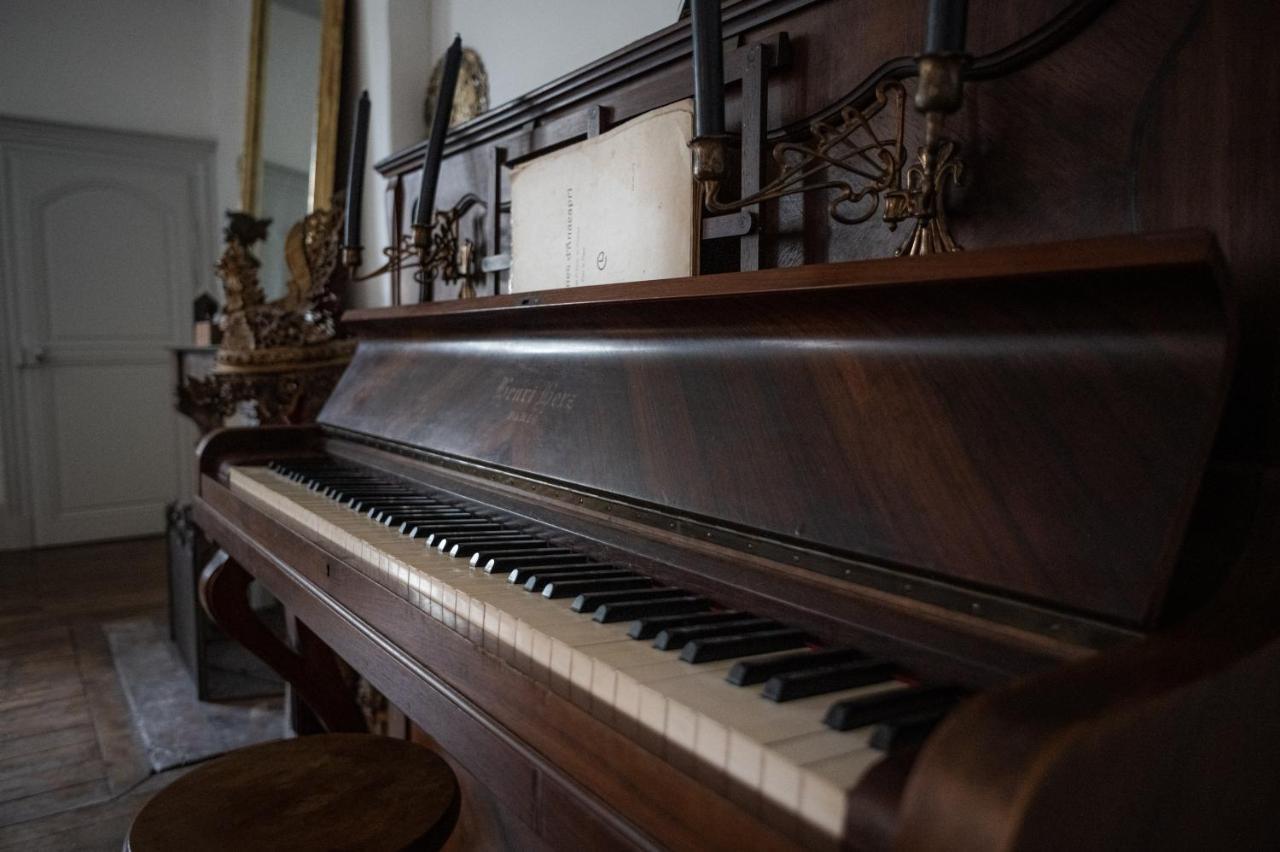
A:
195 232 1280 849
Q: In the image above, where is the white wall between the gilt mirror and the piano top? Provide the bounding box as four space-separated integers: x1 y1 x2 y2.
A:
352 0 680 307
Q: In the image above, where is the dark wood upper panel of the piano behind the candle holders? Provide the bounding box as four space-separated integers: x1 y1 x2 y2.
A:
366 0 1280 478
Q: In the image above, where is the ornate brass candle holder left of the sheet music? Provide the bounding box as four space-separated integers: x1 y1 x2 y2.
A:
343 193 485 302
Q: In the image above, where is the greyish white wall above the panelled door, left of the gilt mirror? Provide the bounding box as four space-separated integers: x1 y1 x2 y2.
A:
0 0 251 245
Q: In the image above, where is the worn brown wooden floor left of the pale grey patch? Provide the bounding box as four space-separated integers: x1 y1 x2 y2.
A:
0 539 186 852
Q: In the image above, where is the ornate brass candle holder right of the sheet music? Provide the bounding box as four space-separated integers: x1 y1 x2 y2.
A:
690 54 969 255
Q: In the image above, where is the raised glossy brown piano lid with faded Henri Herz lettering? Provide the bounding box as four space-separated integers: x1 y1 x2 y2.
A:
319 233 1234 626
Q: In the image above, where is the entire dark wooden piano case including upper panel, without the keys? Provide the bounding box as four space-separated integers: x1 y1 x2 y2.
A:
196 0 1280 851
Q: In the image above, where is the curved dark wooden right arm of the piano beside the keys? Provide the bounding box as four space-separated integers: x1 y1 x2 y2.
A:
899 472 1280 852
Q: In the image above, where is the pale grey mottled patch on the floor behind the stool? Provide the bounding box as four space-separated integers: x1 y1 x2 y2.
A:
102 618 284 773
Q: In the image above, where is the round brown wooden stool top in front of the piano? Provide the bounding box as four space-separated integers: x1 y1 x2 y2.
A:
124 734 460 852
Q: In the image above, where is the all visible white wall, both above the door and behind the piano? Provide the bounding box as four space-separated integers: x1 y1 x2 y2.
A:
0 0 678 303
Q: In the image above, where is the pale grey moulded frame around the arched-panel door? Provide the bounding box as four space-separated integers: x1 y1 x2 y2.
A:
0 115 218 550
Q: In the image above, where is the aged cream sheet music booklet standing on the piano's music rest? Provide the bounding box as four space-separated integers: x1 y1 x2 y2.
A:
511 100 698 293
